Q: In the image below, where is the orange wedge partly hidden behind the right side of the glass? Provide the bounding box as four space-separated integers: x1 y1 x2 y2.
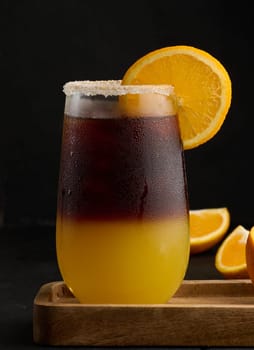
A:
190 208 230 254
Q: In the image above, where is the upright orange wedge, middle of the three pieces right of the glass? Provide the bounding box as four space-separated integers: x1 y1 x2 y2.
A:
215 225 249 278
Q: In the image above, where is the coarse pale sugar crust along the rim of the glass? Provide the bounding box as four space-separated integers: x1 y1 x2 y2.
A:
63 80 174 97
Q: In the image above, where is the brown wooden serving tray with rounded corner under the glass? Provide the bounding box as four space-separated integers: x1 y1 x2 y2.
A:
33 280 254 346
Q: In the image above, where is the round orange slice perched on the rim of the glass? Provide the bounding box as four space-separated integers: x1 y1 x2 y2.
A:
122 45 232 149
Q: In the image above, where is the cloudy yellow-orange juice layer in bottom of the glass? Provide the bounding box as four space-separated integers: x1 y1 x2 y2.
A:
56 216 189 304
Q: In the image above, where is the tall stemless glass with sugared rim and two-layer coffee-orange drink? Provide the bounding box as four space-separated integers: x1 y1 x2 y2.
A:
56 81 189 304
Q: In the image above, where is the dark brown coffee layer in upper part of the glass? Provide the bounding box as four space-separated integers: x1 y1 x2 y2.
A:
58 115 189 220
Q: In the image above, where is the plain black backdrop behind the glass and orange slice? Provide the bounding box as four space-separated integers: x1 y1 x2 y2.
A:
0 0 254 228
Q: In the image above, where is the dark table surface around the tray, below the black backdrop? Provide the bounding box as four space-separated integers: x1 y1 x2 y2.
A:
0 226 254 349
